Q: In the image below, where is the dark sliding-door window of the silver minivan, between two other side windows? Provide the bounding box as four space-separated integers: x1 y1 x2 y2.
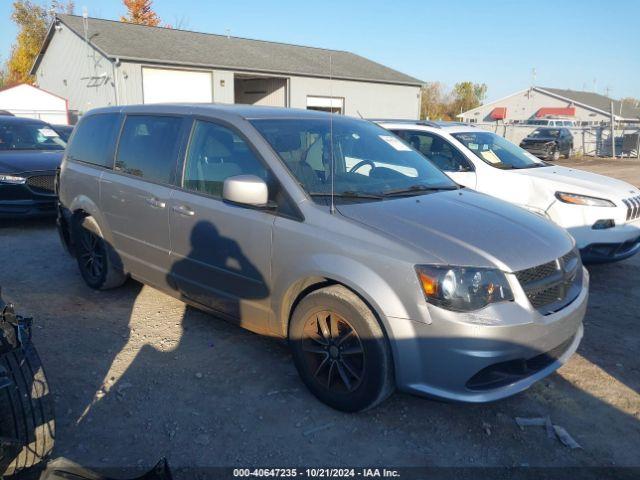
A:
116 115 182 183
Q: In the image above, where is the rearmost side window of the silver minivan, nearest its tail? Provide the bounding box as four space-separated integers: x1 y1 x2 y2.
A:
67 113 120 168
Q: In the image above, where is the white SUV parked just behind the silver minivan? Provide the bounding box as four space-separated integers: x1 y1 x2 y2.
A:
381 121 640 262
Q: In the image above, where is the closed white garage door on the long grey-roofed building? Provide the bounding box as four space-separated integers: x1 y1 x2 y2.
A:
142 67 213 103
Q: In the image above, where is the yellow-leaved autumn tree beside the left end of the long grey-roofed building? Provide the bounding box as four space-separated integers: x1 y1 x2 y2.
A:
4 0 74 86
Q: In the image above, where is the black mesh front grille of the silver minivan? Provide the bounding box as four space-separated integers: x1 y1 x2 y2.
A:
515 250 582 315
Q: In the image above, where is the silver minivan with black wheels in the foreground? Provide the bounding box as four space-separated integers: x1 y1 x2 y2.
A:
59 105 589 411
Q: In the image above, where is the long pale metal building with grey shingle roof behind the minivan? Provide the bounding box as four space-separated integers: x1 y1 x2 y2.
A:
32 15 422 123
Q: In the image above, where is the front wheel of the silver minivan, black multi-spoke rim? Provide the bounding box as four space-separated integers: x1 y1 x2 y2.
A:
289 285 395 412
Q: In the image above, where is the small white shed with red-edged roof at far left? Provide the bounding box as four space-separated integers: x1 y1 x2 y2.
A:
0 84 69 125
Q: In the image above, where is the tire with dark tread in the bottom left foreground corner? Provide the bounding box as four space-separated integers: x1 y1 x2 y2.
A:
0 343 55 476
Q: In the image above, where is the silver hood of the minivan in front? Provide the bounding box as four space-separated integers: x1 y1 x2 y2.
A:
337 189 573 272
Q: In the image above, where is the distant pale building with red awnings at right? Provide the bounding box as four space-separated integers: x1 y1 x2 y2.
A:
458 87 640 126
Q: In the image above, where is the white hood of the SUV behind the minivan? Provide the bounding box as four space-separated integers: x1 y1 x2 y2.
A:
512 165 638 200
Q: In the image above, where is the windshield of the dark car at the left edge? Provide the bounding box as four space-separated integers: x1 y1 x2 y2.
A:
0 122 67 151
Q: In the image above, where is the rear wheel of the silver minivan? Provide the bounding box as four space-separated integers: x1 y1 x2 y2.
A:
73 217 127 290
